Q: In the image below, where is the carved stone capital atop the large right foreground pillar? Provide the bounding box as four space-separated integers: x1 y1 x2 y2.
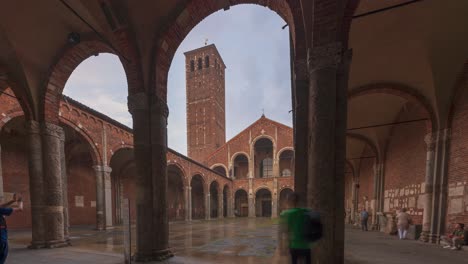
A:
307 42 343 73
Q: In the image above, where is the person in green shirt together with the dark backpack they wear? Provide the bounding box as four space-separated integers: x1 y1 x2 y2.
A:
279 192 322 264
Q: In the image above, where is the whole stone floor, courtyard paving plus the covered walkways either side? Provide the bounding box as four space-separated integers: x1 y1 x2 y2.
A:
7 218 468 264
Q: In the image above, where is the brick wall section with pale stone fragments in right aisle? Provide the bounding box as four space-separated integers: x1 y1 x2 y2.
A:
384 103 428 223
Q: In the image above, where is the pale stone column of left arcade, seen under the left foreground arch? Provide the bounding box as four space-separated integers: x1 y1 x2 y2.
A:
93 165 112 230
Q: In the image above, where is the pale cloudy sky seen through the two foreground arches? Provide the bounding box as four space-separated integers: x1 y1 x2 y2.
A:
64 5 292 154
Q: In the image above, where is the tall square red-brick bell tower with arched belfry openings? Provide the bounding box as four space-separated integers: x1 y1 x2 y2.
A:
184 44 226 162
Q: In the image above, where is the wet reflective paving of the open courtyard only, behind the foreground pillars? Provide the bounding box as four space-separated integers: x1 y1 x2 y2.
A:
10 218 287 263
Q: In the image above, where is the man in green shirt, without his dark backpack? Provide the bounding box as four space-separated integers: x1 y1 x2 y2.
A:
279 193 312 264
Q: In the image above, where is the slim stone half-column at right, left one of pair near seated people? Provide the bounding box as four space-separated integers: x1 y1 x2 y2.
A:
418 133 437 242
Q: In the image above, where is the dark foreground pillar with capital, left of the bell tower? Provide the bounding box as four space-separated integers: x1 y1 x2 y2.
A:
128 93 172 262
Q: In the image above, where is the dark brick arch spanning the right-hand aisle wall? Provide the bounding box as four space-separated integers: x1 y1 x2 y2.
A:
348 82 439 132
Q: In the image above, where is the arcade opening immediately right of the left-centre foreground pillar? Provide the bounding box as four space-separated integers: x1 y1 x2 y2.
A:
167 164 185 221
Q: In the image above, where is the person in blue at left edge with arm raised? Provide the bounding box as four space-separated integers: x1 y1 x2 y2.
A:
0 194 23 264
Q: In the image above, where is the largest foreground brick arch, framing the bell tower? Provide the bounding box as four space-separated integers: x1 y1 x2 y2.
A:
152 0 305 101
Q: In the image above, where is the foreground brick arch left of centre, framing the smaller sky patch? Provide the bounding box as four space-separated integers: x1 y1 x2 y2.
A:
40 35 143 124
